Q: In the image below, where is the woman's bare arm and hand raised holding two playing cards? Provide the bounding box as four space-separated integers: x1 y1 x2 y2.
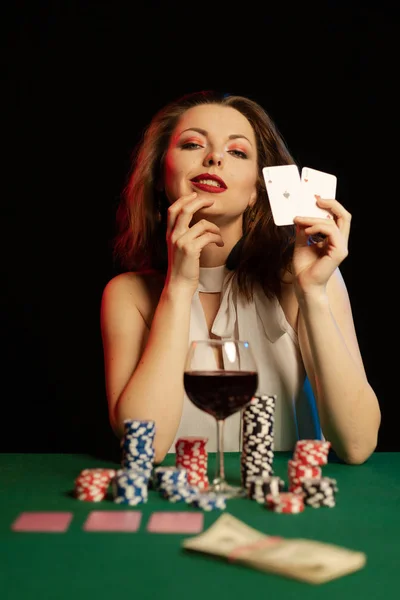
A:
293 197 381 464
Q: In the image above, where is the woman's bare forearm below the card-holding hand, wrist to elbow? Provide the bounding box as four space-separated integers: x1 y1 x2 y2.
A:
298 269 380 464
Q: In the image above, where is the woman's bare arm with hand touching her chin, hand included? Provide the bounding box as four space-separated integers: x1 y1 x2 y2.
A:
101 193 224 462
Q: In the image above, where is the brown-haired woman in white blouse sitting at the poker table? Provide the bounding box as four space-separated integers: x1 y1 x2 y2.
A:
101 92 380 464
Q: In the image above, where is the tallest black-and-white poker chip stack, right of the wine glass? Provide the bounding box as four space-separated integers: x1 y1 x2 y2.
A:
240 395 276 491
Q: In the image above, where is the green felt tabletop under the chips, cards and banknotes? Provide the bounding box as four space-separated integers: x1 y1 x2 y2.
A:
0 452 400 600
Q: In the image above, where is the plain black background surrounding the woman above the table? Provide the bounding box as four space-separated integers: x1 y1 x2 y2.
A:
0 0 400 454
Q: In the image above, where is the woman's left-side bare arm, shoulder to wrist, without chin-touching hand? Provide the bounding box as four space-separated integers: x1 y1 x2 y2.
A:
101 274 191 462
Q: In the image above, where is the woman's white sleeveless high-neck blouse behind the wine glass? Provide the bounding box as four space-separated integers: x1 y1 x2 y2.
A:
169 265 323 452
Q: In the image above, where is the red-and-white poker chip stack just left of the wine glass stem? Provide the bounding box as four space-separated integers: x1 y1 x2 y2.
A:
175 436 209 490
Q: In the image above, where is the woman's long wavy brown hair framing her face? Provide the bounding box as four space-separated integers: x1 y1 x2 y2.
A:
113 90 296 300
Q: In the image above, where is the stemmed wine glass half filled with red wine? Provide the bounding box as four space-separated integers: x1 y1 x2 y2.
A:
183 339 258 498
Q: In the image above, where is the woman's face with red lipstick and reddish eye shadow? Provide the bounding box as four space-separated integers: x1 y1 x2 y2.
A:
164 104 258 223
